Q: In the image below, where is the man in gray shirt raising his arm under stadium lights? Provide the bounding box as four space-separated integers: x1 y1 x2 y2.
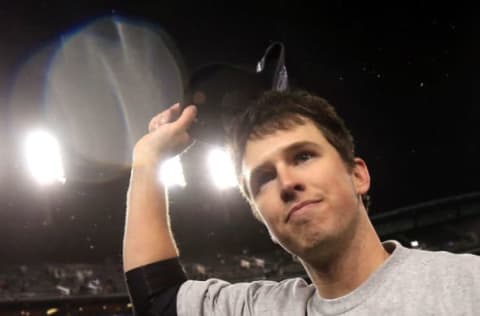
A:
124 91 480 315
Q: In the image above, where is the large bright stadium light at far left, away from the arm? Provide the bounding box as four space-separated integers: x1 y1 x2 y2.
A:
25 130 66 184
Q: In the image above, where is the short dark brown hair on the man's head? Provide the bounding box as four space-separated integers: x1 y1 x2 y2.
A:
227 90 368 218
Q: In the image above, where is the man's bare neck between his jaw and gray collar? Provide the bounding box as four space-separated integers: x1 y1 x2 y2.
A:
302 215 388 299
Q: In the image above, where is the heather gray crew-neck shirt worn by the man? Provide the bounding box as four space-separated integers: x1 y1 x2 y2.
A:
177 241 480 316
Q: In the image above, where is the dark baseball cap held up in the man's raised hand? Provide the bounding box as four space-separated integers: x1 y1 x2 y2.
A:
182 42 289 145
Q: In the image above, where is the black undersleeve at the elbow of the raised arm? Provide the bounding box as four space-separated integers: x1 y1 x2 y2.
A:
125 258 187 316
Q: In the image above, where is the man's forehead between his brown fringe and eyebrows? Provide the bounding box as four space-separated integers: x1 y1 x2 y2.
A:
242 119 328 177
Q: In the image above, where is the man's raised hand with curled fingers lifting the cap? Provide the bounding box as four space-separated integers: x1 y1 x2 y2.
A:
133 103 197 166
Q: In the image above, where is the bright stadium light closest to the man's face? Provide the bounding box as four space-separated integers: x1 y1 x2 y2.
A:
208 148 237 189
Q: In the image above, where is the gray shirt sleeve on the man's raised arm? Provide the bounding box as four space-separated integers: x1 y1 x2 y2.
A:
177 278 314 316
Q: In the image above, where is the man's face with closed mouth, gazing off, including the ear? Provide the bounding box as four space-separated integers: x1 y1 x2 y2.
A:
242 119 370 259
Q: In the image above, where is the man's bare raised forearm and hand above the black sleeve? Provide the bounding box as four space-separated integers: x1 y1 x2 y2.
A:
123 104 196 271
